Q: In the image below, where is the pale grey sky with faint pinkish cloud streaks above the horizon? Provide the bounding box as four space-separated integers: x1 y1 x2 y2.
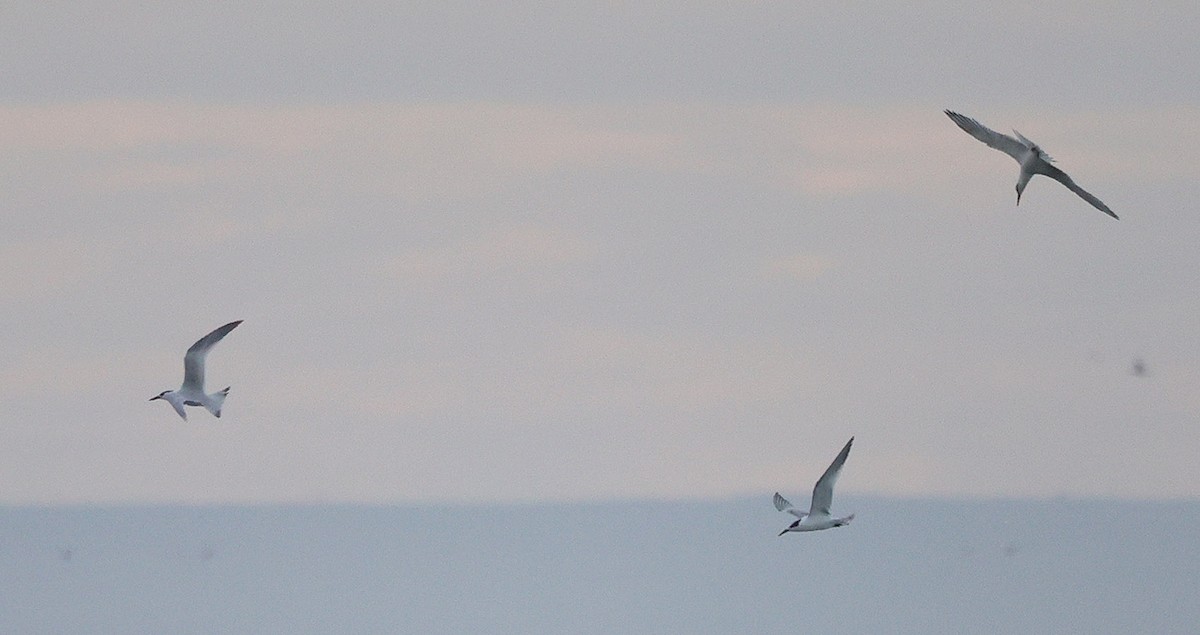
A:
0 1 1200 503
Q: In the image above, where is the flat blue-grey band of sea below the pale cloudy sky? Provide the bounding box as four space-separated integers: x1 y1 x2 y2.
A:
0 495 1200 635
